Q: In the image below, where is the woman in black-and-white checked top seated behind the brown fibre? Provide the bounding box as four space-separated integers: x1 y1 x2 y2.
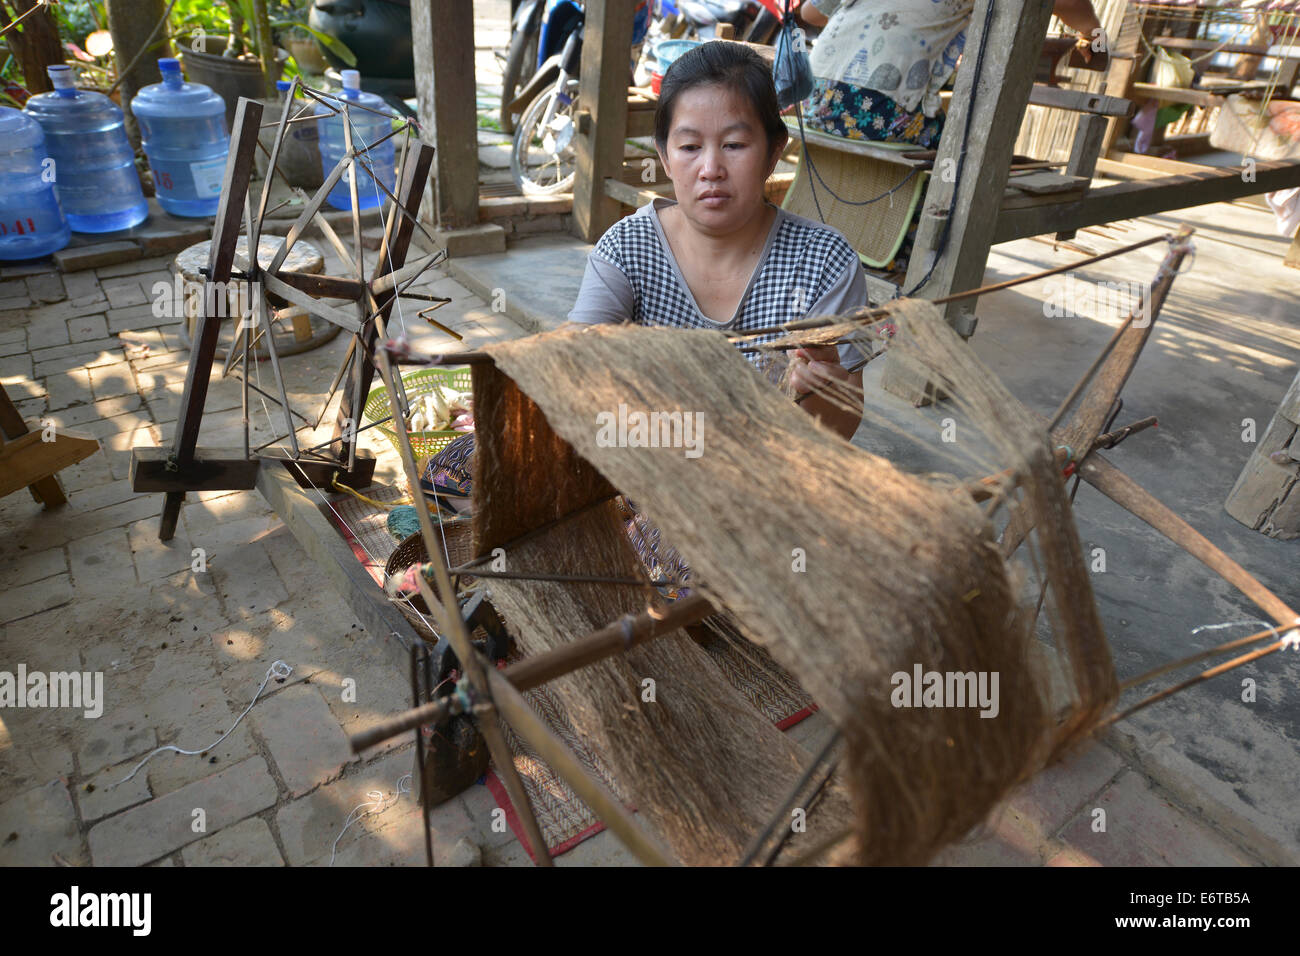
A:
423 40 867 590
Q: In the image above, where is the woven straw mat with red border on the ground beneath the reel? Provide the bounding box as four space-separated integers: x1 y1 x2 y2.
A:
330 485 816 856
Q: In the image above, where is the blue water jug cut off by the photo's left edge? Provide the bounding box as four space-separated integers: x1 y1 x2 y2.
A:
0 107 72 260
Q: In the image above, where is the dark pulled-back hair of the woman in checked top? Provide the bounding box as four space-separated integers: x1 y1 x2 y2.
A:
654 40 789 152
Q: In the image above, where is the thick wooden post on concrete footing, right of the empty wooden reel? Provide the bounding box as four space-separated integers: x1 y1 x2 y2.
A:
411 0 478 229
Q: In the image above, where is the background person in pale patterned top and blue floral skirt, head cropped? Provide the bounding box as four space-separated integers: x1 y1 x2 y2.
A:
798 0 1101 150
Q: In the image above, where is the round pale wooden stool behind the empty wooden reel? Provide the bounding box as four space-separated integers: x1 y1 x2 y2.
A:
172 235 341 359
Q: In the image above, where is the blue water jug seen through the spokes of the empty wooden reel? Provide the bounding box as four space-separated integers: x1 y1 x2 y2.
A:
316 70 398 209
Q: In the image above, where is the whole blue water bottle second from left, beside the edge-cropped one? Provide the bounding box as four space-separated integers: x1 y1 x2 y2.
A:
23 64 150 233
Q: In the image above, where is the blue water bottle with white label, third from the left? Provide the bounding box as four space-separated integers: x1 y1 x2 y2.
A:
131 57 230 217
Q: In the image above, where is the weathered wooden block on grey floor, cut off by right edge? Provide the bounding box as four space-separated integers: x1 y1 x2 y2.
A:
1223 375 1300 540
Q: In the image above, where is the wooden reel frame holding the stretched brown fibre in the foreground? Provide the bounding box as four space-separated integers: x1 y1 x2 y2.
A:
352 228 1300 864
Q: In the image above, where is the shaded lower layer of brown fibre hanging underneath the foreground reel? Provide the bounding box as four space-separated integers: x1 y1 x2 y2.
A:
475 367 849 865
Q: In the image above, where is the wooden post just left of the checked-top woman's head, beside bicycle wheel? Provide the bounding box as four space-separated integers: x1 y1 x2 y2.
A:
573 0 636 242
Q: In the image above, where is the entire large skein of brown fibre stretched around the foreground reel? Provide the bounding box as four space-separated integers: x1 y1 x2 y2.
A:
475 307 1114 864
